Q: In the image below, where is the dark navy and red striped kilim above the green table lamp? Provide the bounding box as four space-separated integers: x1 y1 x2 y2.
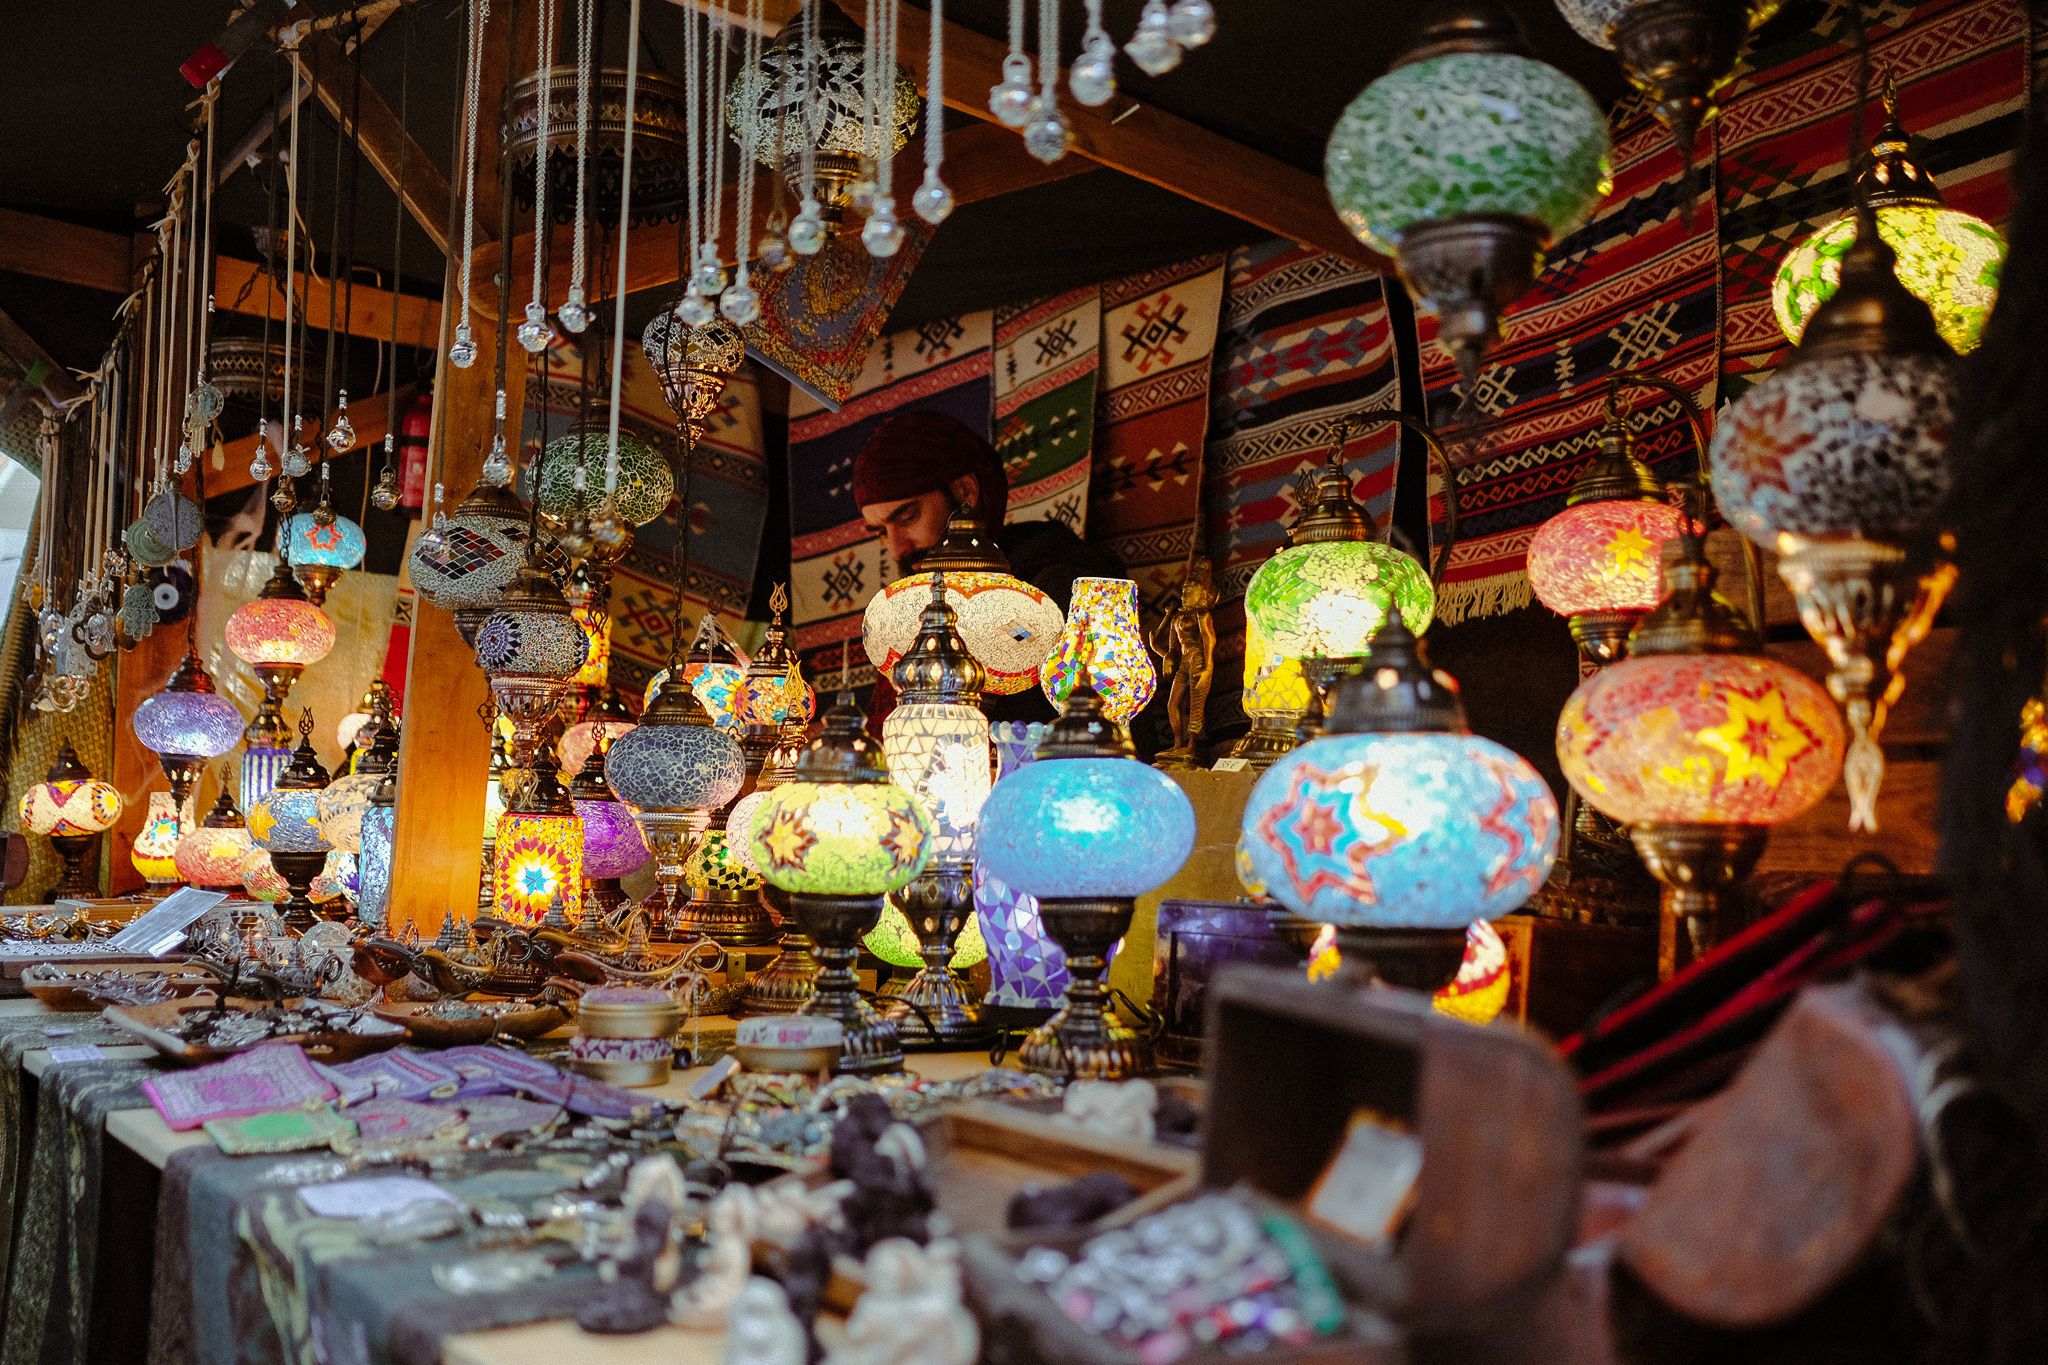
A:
1202 239 1401 731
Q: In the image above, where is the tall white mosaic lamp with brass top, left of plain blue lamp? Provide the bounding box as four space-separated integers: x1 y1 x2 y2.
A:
868 571 995 1048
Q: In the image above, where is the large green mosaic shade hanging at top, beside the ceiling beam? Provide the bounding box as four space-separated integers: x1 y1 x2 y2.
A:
1323 51 1610 256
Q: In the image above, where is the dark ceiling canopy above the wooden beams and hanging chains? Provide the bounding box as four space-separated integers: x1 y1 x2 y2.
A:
0 0 1622 383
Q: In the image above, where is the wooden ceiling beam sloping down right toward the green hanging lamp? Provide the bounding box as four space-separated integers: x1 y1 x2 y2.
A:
823 0 1393 272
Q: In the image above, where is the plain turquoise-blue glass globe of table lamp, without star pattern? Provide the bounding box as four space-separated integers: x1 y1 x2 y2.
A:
979 757 1194 900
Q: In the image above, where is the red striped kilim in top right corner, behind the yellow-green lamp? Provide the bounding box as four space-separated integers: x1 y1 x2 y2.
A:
1714 0 2028 399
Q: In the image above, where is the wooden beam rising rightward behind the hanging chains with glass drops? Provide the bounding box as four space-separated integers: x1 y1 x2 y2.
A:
473 123 1096 319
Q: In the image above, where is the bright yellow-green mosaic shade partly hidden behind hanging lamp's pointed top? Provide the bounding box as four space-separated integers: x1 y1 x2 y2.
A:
1772 205 2005 354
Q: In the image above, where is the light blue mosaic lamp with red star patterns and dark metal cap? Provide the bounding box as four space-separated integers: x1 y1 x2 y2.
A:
1243 612 1559 993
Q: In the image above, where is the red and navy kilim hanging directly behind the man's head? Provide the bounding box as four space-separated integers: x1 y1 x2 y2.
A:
788 313 993 688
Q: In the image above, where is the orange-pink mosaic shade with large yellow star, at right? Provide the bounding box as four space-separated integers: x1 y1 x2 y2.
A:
1556 655 1845 825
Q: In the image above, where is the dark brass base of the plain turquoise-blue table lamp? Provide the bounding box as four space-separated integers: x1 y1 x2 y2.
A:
1018 898 1153 1081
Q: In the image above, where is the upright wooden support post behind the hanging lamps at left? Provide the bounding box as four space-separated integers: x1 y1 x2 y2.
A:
391 2 535 933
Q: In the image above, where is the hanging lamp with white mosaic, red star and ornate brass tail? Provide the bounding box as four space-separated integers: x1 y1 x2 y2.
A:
1712 205 1958 831
